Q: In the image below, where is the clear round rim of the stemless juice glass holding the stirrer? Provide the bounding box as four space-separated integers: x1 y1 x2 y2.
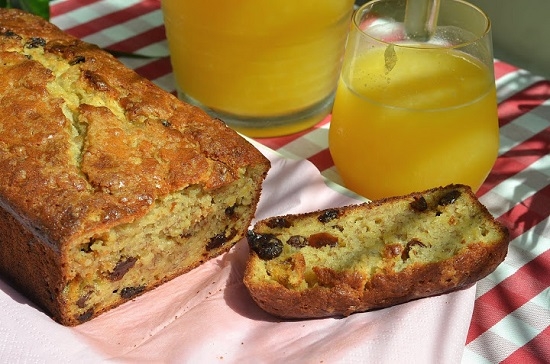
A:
352 0 491 49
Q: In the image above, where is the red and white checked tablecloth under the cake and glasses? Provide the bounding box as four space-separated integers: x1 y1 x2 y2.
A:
40 0 550 363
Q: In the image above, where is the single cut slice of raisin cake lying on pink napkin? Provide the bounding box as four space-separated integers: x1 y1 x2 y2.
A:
244 185 509 318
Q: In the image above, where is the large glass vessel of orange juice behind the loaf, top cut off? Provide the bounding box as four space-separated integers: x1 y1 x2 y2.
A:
162 0 353 137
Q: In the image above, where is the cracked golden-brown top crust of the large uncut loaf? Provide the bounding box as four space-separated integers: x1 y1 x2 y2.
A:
0 9 269 250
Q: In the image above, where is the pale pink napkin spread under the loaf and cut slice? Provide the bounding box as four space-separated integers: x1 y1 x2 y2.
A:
0 146 475 363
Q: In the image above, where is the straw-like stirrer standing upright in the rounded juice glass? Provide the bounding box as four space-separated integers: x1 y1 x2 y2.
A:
405 0 440 41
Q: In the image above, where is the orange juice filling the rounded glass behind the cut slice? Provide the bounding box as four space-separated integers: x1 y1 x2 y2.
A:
329 46 499 199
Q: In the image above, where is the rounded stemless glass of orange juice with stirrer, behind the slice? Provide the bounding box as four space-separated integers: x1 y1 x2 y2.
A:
329 0 499 199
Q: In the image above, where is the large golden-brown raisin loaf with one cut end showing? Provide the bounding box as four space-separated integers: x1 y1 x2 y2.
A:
0 9 269 325
